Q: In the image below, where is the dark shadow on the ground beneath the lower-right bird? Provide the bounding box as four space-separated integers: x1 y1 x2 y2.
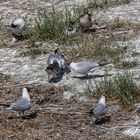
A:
93 116 111 125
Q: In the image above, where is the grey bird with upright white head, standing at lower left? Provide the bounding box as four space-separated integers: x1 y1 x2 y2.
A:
7 88 31 116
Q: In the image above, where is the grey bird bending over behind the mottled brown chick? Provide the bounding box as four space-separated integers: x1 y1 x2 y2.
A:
47 48 66 67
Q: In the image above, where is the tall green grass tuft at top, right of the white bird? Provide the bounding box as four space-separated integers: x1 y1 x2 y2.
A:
31 6 80 43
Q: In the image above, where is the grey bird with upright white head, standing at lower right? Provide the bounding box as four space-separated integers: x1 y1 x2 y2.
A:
91 96 107 119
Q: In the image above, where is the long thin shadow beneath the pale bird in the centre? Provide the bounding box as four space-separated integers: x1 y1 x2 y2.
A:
73 74 112 80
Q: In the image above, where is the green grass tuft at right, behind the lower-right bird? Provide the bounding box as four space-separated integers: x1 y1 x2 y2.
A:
95 72 140 108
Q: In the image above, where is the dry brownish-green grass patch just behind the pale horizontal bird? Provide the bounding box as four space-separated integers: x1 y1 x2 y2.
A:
64 35 125 64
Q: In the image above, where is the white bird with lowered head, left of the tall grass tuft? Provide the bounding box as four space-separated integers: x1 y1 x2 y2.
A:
11 17 26 42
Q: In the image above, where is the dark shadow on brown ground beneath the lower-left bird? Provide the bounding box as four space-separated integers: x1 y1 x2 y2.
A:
8 111 37 120
